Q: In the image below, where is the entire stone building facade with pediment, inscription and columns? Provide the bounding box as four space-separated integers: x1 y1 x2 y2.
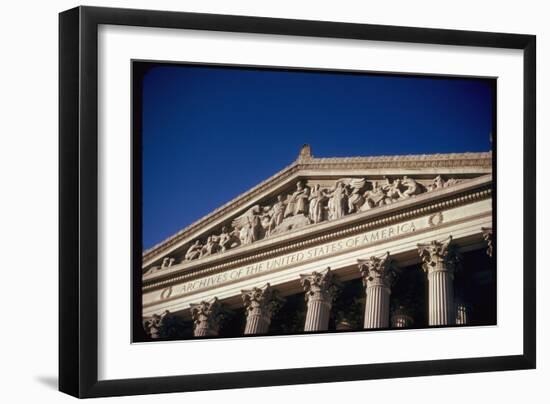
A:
142 145 496 339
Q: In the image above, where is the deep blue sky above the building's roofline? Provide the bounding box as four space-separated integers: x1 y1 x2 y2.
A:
142 65 493 248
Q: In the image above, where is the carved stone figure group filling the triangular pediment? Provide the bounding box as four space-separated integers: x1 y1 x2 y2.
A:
174 175 460 265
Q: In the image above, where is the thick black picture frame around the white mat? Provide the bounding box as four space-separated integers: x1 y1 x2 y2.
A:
59 7 536 398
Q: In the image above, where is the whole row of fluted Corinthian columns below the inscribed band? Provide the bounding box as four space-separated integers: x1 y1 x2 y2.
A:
146 229 492 338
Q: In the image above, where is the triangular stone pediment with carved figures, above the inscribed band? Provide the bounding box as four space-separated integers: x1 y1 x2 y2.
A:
143 149 492 273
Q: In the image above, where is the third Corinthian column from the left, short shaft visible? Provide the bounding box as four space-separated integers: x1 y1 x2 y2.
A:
241 283 283 335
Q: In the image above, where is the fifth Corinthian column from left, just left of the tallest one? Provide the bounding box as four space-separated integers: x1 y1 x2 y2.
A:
358 252 395 328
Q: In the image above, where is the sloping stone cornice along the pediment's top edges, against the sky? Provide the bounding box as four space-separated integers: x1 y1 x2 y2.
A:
142 152 492 263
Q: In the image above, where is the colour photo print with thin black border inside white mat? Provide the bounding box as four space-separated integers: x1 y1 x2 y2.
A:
136 61 498 342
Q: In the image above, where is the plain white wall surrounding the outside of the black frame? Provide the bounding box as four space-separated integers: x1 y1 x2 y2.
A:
0 0 550 404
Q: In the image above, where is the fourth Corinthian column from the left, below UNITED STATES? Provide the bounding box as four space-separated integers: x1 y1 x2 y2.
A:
300 268 336 331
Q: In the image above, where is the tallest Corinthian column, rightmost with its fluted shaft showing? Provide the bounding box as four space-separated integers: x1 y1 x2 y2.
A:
418 236 457 325
